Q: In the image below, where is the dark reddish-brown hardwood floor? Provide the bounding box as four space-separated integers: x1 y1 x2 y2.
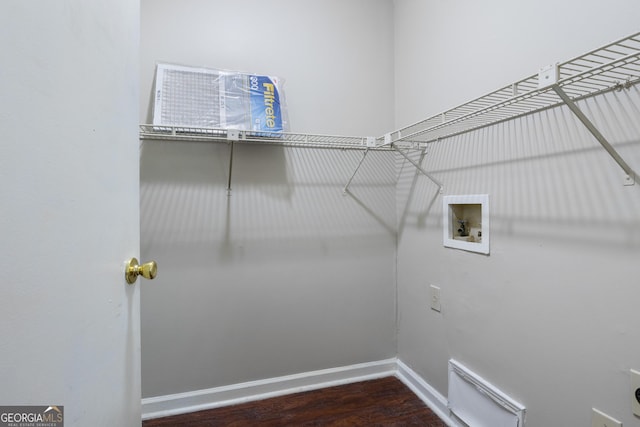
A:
142 377 446 427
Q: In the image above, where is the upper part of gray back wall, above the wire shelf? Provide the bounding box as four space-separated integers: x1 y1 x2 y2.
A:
140 0 394 136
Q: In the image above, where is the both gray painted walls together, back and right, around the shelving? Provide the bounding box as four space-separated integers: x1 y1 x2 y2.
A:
140 0 640 427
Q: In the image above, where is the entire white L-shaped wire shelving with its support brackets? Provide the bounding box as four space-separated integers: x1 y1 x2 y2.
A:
140 32 640 192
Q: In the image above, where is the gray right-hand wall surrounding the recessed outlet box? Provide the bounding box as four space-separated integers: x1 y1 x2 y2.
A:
394 0 640 427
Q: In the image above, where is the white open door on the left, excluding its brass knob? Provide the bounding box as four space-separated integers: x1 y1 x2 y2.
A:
0 0 141 427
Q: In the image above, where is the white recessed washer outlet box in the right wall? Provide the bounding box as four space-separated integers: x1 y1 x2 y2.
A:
442 194 489 254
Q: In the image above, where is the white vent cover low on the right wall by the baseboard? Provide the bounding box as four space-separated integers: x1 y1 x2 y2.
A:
449 359 525 427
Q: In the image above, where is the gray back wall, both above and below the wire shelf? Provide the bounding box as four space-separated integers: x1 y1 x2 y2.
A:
140 0 397 397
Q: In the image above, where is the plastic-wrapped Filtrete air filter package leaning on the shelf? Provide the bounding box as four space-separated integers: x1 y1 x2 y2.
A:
153 64 288 136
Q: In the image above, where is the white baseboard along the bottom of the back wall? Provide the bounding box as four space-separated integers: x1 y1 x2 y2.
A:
142 358 398 420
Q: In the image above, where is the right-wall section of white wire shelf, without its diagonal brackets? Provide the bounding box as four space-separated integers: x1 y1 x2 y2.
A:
378 33 640 145
